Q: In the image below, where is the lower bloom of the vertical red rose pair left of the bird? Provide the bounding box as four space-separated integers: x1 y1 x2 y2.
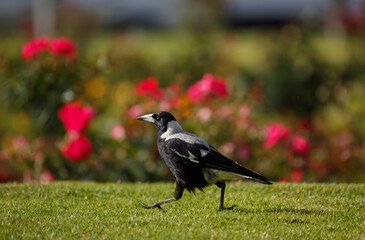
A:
62 134 92 162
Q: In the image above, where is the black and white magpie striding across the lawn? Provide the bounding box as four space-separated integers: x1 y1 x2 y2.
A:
137 111 271 211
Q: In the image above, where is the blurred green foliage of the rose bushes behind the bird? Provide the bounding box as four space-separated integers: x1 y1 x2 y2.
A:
0 31 365 182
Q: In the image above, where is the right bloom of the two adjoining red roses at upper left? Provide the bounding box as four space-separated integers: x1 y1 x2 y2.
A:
50 37 77 60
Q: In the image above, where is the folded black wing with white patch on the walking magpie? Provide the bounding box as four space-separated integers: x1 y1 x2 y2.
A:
166 138 271 184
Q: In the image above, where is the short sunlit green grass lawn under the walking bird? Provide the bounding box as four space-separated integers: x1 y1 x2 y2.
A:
0 182 365 239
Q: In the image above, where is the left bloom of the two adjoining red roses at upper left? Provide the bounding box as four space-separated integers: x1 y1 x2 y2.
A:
22 37 49 60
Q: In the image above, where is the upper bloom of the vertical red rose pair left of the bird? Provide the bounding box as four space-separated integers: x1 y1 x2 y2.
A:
58 102 95 132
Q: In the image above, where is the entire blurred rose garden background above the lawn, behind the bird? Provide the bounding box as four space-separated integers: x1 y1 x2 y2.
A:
0 0 365 182
